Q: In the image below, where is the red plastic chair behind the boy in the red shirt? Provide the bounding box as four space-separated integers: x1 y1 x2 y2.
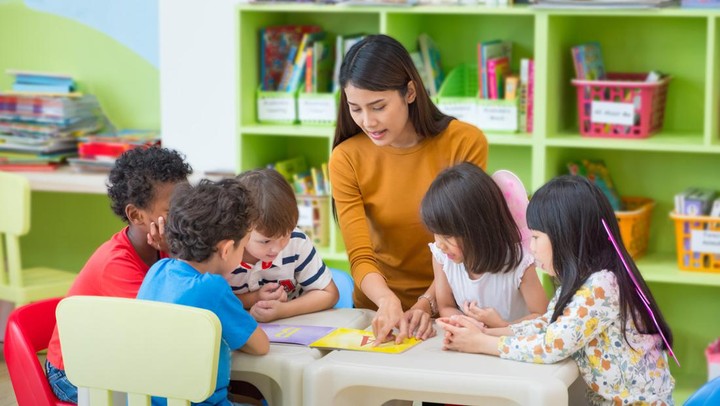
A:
4 298 70 406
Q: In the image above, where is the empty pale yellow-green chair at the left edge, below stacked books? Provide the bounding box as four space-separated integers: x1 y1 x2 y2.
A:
0 171 76 306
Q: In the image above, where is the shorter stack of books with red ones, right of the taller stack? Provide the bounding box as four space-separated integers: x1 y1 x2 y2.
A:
68 129 160 172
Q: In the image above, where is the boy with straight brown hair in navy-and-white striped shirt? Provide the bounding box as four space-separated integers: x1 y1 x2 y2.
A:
228 169 339 322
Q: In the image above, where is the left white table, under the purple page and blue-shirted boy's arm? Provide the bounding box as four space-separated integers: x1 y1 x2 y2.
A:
231 309 375 406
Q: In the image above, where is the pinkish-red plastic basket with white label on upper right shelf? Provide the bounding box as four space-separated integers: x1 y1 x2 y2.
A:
572 73 670 139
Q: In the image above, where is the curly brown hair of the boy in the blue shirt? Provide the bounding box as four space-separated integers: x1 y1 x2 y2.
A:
165 179 257 262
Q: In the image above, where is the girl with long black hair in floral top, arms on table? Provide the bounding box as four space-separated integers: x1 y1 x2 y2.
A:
438 176 674 405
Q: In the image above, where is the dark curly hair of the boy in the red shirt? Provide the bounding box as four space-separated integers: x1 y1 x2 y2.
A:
107 147 192 223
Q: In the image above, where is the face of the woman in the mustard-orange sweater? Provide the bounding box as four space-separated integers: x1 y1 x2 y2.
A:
345 82 418 148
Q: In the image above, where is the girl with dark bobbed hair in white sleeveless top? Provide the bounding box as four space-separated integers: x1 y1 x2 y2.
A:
420 162 548 327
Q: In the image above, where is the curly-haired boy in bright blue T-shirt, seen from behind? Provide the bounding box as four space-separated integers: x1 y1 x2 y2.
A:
137 179 270 405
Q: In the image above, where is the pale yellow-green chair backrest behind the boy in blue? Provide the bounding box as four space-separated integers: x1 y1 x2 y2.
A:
57 296 221 406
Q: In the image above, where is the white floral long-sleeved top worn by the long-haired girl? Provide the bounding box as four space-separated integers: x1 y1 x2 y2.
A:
498 271 675 405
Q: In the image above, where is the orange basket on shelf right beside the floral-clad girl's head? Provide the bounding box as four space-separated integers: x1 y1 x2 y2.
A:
615 197 655 259
